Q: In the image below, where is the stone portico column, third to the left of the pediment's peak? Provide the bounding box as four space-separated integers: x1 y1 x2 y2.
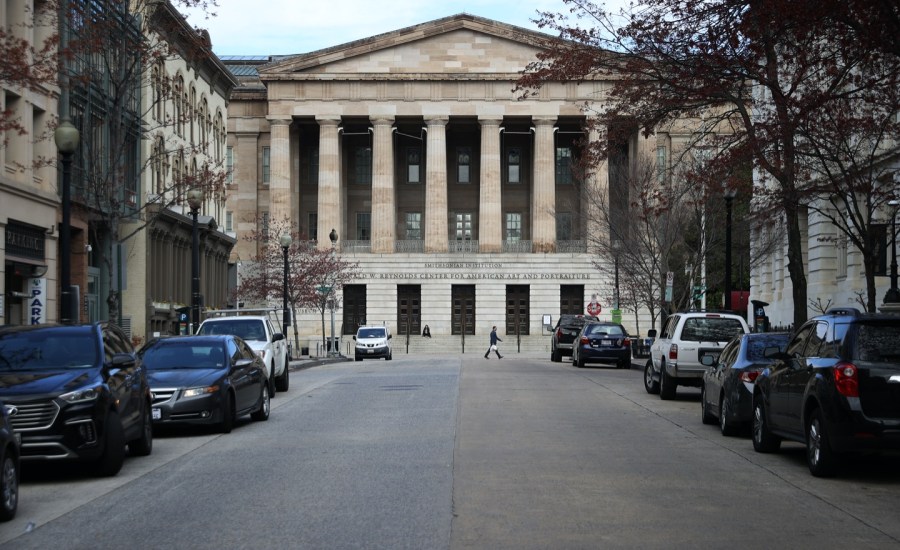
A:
316 117 347 250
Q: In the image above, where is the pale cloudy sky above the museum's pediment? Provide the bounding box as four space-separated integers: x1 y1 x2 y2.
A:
182 0 626 56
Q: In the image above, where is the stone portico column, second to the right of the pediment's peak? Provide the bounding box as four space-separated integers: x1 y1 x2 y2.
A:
531 117 556 253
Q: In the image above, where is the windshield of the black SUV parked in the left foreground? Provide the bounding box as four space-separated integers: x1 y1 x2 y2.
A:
0 329 99 371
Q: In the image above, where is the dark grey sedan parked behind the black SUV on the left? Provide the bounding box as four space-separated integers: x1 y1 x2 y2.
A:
139 335 272 433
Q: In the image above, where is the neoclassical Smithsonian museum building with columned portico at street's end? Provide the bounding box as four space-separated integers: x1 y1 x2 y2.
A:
222 14 660 353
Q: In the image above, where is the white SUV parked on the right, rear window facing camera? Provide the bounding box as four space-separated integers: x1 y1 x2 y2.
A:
644 312 750 399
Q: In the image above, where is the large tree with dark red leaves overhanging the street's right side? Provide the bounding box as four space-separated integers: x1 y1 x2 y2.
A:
518 0 900 325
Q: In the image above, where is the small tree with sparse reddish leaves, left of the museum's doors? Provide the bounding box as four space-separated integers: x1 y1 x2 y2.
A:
236 220 359 358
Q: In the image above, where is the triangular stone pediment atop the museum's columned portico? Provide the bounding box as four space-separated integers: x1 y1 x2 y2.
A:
260 14 551 77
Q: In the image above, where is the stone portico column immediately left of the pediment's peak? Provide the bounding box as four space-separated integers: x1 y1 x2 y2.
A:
425 116 450 253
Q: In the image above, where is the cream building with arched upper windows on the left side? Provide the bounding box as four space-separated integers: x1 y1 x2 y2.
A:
122 0 237 343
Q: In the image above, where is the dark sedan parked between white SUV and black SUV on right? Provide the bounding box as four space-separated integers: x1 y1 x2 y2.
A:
700 332 790 435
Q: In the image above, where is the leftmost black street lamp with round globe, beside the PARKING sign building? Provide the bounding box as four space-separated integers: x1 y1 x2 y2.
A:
53 119 81 323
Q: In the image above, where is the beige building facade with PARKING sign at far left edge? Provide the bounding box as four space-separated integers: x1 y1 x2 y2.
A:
0 0 59 325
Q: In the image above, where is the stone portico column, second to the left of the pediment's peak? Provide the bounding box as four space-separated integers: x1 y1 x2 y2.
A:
370 116 397 254
